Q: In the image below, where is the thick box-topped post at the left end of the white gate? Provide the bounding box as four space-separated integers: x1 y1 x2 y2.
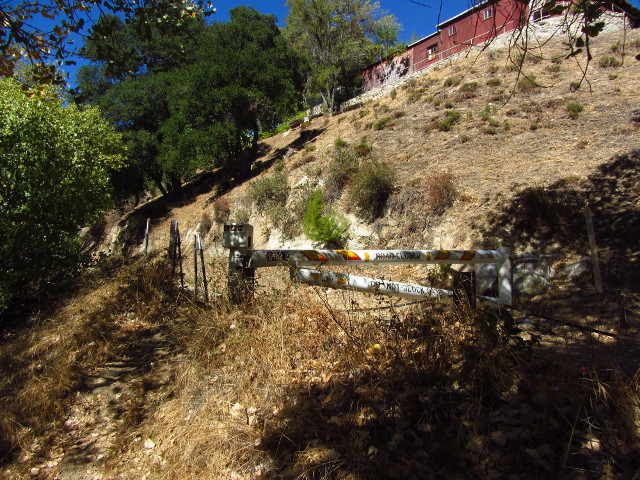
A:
222 223 255 304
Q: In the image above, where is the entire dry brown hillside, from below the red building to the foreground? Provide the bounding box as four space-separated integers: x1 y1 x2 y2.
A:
0 31 640 480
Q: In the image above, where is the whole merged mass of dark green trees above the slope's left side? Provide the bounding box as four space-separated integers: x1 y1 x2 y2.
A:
78 7 305 195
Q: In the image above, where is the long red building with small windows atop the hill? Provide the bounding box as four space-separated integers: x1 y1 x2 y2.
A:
362 0 640 91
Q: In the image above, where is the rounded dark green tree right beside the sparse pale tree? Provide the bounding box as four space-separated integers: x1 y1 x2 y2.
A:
162 7 306 178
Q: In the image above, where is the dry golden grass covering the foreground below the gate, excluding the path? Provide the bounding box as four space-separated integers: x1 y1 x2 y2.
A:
2 253 640 480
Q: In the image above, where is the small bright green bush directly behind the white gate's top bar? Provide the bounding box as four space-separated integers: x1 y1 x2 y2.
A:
302 189 349 248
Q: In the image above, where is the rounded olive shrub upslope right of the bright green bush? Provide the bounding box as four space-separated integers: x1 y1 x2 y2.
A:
349 160 395 222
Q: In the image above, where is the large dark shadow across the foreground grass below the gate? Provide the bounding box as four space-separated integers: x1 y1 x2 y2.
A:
260 306 640 480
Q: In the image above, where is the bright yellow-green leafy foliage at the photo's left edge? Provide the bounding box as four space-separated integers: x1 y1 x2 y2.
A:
0 79 123 310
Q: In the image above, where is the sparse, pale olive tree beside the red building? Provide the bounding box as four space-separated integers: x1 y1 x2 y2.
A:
285 0 400 111
